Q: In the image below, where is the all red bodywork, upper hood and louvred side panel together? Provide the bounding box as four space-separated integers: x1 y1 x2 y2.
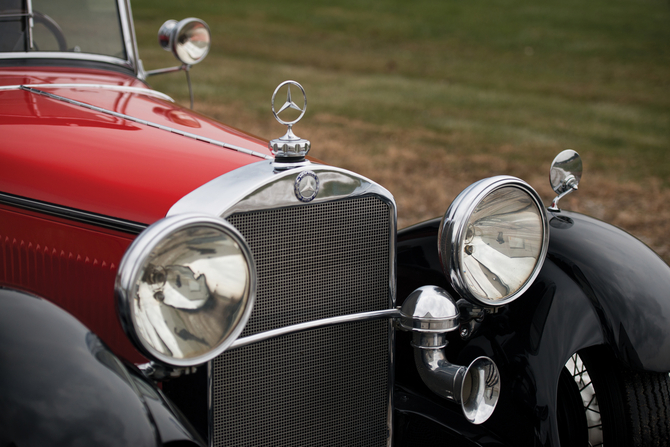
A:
0 67 271 362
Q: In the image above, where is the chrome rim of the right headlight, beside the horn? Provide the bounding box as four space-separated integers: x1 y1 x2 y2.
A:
438 175 549 307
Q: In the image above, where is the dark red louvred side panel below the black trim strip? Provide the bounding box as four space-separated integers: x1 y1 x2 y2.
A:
0 205 146 362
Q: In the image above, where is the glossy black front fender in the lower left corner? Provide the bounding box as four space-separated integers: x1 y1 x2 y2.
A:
0 289 204 447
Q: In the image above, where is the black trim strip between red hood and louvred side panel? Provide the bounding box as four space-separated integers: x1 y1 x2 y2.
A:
0 192 147 234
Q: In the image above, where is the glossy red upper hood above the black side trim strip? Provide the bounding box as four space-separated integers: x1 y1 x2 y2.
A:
0 68 271 224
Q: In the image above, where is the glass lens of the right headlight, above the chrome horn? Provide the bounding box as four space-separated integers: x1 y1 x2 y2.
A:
461 187 544 300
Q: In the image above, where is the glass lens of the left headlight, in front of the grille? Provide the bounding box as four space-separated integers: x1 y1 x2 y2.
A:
133 226 250 359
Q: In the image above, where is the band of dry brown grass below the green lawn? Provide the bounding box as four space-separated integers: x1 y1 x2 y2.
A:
198 103 670 262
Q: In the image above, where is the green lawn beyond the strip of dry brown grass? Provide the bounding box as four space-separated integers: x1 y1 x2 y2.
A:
133 0 670 187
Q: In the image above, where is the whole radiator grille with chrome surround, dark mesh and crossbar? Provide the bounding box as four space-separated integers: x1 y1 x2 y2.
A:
186 161 398 447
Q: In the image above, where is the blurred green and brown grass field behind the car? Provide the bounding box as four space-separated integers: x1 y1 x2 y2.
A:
133 0 670 260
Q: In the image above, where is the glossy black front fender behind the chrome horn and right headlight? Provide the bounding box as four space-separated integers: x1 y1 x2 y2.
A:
396 212 670 445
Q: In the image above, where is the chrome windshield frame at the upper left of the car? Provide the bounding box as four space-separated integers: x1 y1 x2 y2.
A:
0 0 142 76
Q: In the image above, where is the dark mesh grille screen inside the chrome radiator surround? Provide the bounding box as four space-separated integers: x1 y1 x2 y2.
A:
212 196 391 447
